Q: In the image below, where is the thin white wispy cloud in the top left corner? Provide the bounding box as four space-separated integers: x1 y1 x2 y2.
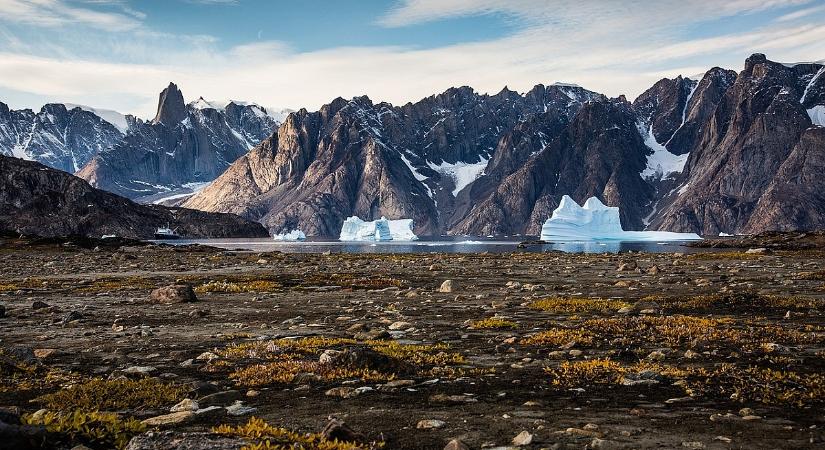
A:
0 0 141 31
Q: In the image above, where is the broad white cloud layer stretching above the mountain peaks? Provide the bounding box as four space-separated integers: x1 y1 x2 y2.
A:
0 0 825 117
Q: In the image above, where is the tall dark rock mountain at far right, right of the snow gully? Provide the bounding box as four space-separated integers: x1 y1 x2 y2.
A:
652 54 825 234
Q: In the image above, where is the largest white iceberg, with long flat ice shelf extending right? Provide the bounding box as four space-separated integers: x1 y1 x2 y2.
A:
541 195 702 242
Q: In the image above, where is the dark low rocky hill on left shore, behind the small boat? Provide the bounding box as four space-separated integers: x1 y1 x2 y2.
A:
0 156 267 239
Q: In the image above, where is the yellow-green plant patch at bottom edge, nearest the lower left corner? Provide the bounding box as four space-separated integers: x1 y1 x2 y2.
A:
22 411 146 449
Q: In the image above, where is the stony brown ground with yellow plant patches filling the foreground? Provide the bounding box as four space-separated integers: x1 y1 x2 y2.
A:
0 240 825 450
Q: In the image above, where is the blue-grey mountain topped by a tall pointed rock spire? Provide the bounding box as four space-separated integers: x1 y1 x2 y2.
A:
78 83 277 201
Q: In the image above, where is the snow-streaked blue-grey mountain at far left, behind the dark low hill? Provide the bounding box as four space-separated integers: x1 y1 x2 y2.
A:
0 103 123 172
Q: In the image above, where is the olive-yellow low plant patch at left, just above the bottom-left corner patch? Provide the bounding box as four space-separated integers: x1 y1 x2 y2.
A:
35 378 187 411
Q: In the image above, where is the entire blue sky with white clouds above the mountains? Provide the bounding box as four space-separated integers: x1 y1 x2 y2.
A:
0 0 825 118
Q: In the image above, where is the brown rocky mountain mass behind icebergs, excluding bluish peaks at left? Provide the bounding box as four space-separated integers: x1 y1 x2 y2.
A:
184 55 825 236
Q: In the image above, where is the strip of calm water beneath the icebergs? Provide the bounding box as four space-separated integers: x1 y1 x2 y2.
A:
163 237 707 253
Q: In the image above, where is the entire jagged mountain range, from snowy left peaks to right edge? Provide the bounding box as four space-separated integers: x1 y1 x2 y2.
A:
0 54 825 236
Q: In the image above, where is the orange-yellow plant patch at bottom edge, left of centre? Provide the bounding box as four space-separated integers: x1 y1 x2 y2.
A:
212 417 384 450
